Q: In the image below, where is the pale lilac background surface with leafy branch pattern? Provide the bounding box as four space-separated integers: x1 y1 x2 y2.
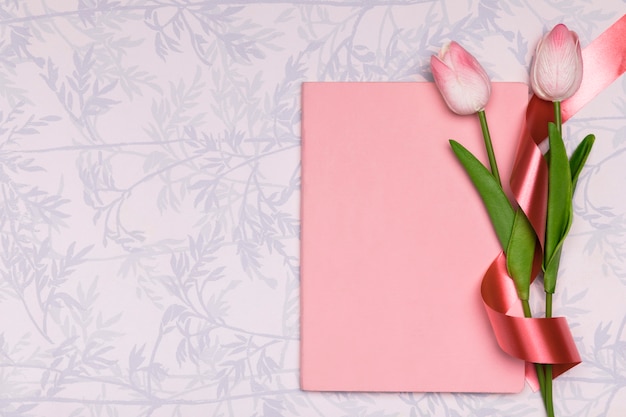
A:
0 0 626 417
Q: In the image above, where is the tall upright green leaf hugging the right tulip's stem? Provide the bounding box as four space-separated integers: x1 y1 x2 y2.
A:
543 123 573 293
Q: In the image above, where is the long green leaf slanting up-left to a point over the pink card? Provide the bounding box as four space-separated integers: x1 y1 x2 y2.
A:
450 140 515 249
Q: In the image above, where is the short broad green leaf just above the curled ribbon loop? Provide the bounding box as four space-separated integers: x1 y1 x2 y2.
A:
505 209 537 300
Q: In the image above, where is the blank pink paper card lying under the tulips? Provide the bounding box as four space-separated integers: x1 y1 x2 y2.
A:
301 83 528 392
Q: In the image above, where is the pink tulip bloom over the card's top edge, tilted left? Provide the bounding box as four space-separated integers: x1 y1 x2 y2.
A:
430 42 491 115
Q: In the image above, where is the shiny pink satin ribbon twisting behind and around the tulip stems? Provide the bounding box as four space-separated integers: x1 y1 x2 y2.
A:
481 15 626 389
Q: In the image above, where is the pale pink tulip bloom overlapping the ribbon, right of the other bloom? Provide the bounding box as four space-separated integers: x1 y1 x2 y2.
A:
530 24 583 102
